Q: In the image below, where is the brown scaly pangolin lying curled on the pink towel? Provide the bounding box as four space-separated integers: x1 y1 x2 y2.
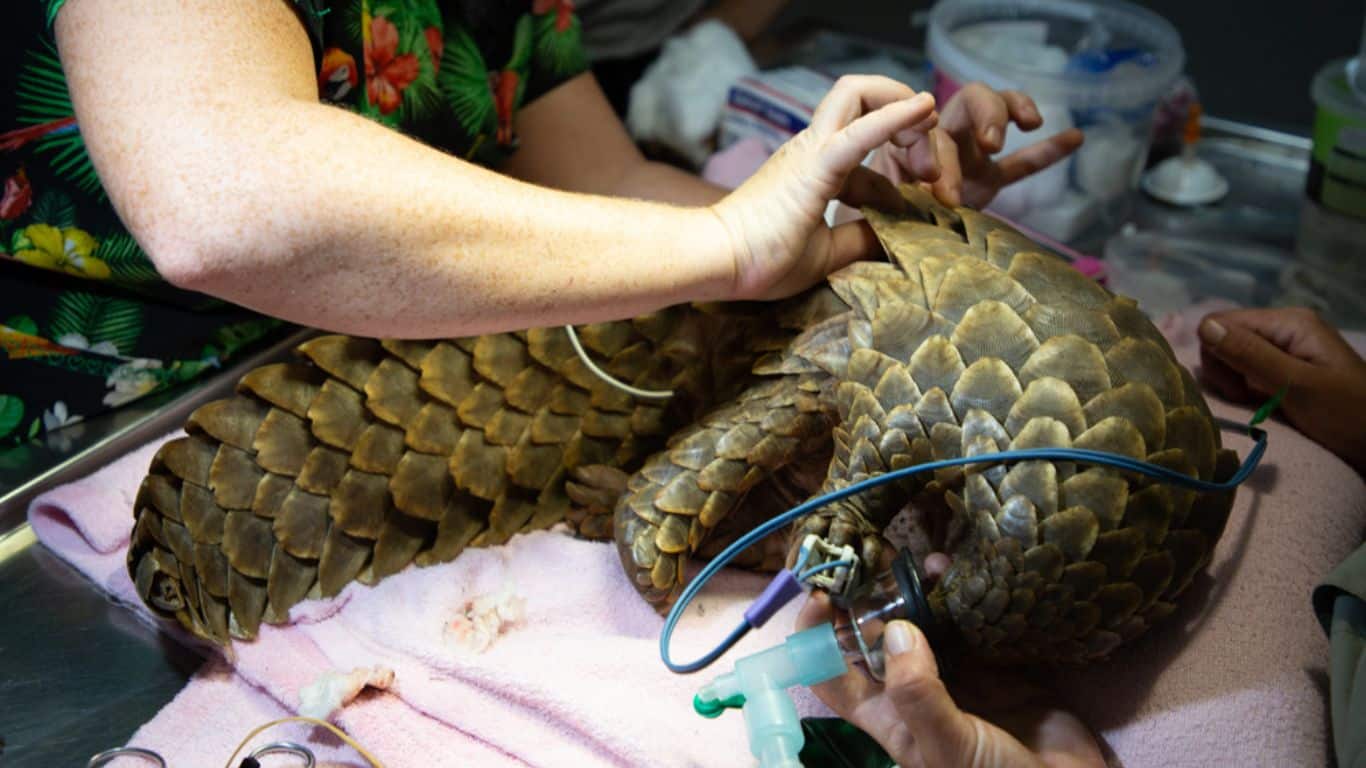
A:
128 186 1238 661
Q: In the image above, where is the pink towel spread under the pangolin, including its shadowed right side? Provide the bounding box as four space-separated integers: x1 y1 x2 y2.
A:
30 300 1366 768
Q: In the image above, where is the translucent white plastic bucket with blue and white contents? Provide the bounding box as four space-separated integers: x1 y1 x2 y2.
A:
926 0 1186 241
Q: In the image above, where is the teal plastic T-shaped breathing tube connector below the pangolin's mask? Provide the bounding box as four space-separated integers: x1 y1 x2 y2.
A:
693 623 848 768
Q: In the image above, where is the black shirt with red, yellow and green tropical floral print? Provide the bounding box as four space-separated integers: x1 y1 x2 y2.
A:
0 0 587 447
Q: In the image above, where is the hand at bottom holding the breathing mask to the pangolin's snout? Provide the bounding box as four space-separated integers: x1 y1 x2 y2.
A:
796 593 1105 768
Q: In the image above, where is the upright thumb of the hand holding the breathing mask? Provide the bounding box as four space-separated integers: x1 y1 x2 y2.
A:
882 620 979 765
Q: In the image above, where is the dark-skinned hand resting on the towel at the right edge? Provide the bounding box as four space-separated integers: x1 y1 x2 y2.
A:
1199 307 1366 474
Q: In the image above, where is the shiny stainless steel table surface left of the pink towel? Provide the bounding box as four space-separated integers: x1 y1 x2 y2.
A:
0 325 311 768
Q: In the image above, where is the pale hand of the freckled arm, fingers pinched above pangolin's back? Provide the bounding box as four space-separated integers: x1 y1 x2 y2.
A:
712 75 938 299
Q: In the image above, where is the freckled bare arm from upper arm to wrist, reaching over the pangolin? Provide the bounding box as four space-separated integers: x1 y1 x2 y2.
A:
56 0 735 338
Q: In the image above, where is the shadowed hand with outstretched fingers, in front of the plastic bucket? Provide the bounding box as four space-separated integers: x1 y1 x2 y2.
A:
873 83 1082 208
